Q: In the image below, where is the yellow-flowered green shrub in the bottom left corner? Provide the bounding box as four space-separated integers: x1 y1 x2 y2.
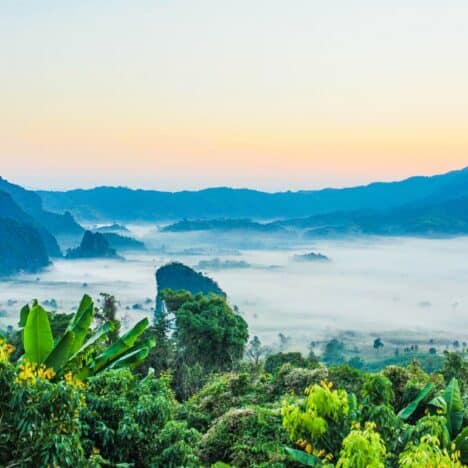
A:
0 361 85 466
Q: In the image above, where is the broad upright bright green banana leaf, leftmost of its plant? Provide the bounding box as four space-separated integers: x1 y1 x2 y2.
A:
23 301 54 364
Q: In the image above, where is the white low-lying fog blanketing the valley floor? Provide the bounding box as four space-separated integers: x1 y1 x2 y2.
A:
0 226 468 345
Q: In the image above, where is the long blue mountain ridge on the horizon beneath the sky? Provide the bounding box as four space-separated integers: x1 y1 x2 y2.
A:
38 168 468 221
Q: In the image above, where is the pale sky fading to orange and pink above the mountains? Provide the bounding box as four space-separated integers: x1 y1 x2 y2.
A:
0 0 468 191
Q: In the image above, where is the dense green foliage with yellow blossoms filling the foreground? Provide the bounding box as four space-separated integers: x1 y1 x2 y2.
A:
0 292 468 468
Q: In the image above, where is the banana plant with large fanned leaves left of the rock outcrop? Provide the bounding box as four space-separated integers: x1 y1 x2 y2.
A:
20 295 155 380
